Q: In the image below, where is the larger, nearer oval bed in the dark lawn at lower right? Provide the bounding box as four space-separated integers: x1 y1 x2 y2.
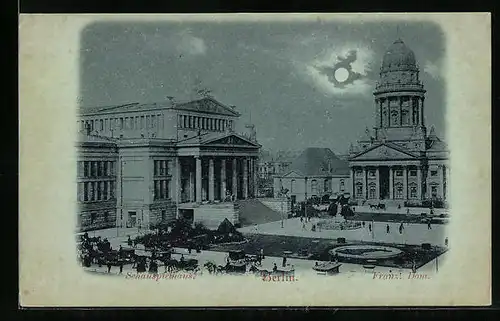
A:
329 244 403 260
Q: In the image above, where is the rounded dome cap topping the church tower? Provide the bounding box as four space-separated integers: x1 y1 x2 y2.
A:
381 39 417 72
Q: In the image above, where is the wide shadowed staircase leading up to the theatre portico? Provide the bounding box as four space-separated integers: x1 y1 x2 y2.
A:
238 199 282 227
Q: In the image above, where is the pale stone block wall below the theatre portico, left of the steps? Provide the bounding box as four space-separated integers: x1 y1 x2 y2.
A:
194 203 240 229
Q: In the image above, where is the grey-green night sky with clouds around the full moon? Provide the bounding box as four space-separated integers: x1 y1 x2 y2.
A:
79 20 446 154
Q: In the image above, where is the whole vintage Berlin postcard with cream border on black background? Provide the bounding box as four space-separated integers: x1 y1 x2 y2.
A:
19 13 491 307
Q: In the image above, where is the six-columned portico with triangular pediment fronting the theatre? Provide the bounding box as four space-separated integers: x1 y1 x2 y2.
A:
177 133 260 204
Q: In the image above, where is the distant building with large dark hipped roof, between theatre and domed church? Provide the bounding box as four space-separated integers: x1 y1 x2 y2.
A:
274 148 350 203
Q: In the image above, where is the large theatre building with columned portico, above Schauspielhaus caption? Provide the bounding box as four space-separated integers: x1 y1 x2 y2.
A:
78 97 260 229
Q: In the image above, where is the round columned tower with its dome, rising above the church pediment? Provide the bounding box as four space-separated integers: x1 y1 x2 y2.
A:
373 39 426 150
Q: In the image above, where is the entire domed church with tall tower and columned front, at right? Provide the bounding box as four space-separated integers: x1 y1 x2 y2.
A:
349 39 449 204
